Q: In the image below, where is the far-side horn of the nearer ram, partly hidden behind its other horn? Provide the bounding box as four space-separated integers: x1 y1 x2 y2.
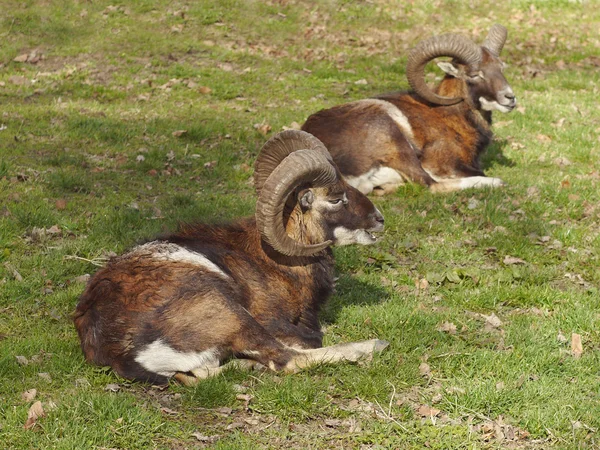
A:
254 130 333 194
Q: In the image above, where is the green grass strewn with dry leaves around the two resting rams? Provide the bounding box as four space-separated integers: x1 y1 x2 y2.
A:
0 0 600 449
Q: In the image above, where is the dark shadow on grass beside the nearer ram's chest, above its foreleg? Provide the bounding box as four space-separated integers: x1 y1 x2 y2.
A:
321 275 390 324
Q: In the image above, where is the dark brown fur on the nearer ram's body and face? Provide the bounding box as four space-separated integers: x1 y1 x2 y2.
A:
74 181 383 383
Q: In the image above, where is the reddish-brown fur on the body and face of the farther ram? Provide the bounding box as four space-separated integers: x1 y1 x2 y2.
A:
302 47 508 193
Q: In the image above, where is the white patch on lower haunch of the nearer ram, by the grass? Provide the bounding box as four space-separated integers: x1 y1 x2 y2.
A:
135 339 219 377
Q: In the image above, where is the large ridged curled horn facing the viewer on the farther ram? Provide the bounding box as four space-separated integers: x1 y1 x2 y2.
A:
406 33 481 106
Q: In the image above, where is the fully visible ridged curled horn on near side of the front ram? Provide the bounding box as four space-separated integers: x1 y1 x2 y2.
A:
256 149 338 256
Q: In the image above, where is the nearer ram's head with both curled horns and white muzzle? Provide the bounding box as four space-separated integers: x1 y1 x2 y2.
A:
254 130 383 256
